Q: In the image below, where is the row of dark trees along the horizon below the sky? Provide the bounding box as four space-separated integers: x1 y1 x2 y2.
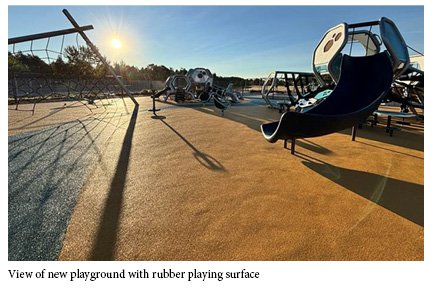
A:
8 46 262 87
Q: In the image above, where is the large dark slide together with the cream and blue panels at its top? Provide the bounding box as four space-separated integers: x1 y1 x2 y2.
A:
261 18 418 154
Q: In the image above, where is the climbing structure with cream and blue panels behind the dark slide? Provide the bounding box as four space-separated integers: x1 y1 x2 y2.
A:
261 17 424 113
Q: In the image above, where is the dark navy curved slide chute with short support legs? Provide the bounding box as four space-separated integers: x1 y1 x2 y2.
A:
261 52 393 154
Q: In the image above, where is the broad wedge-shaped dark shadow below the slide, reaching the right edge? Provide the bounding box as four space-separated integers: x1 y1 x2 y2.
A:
299 156 424 226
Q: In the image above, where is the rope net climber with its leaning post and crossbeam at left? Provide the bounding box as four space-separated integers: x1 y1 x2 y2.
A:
8 9 138 113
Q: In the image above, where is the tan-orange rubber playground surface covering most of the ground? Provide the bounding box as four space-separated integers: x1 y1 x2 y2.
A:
9 97 424 260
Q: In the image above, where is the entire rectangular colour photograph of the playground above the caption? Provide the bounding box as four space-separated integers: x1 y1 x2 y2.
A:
7 6 425 264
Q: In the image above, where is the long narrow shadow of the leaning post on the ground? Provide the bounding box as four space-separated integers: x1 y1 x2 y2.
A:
90 106 138 260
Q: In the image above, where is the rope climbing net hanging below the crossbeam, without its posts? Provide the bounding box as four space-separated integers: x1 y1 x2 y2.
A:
8 29 125 112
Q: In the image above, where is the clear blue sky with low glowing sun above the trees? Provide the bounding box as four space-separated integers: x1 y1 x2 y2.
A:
8 6 424 77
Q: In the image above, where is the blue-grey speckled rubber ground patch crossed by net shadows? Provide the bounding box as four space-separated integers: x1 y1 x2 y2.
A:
8 104 127 261
